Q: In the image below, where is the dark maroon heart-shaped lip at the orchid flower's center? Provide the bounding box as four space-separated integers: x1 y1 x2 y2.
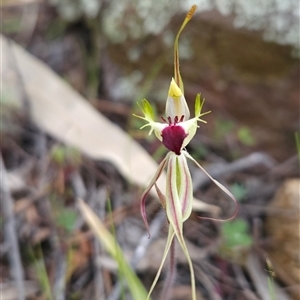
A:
161 116 187 155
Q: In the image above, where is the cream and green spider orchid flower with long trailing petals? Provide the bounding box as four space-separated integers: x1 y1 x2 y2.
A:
135 5 235 300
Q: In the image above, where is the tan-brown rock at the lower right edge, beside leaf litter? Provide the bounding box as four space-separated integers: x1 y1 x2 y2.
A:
266 179 300 299
